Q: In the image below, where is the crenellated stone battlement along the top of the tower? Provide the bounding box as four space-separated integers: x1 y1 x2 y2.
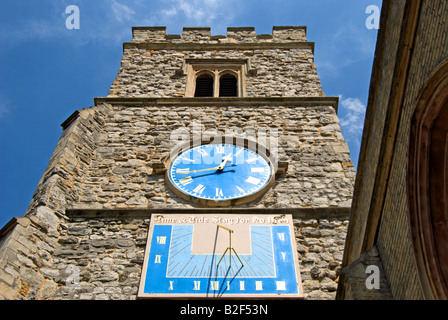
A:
131 26 307 44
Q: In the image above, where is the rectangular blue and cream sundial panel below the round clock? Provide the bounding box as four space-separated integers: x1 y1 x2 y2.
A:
139 213 303 298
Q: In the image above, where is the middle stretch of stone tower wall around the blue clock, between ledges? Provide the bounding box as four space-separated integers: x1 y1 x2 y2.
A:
71 105 354 209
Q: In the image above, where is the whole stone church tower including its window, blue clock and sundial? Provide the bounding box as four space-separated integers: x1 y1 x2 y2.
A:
0 26 355 300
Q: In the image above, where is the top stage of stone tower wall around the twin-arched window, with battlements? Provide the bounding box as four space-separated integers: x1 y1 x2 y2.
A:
109 27 324 97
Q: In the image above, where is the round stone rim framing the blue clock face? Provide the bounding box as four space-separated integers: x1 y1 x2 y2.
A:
165 136 276 207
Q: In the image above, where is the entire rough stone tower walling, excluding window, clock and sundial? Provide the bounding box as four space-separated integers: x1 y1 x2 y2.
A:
0 27 355 299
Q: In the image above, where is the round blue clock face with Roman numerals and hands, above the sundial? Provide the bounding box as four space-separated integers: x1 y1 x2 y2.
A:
168 143 272 201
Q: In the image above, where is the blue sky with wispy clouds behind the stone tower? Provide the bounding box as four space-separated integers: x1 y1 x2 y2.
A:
0 0 381 227
